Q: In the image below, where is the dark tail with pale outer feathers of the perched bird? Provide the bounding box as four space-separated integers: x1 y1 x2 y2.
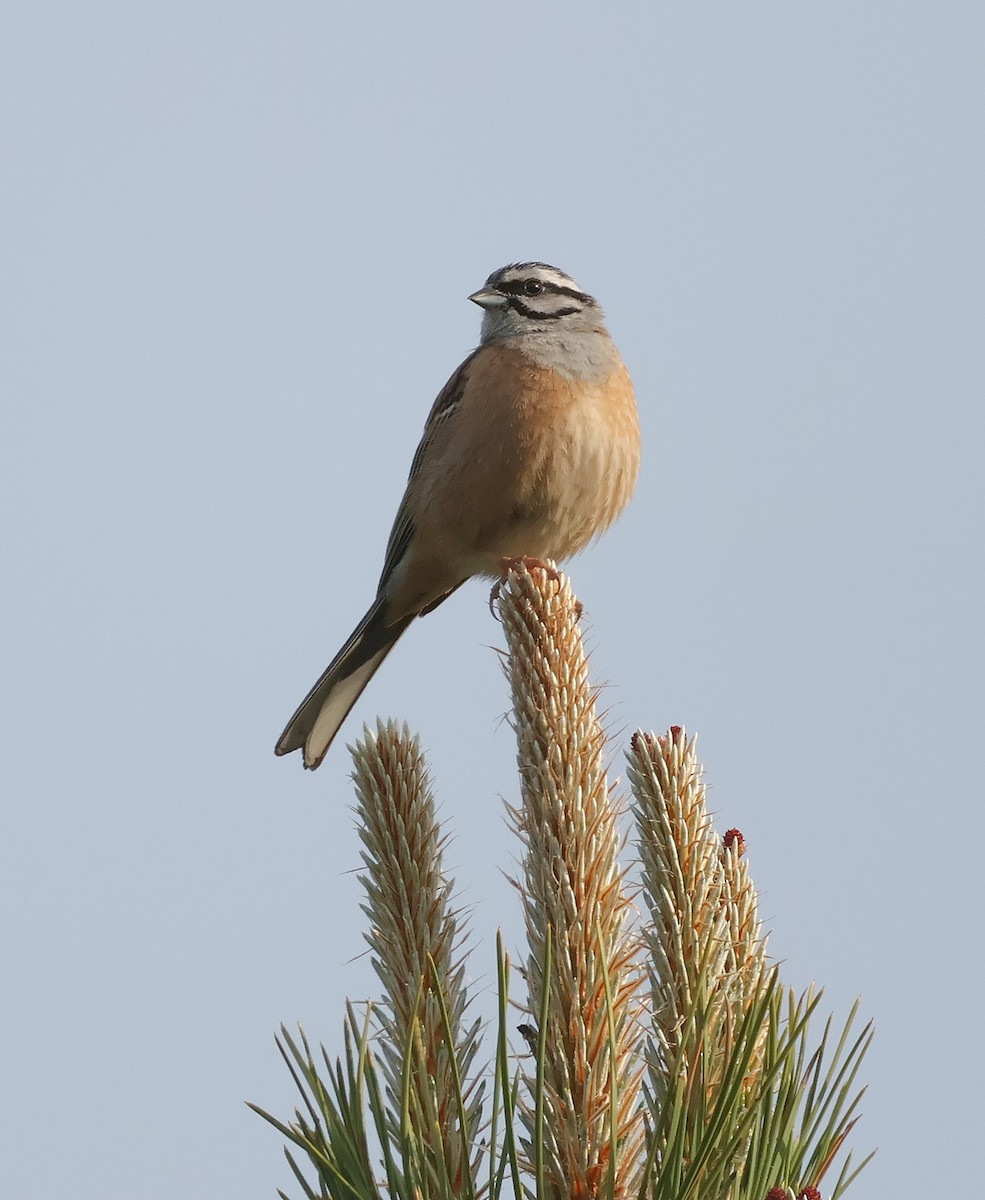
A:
274 596 416 770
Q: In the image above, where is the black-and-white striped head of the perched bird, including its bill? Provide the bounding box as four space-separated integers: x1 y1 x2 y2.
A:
469 263 605 341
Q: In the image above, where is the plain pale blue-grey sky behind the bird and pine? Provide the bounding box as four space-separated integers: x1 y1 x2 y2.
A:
0 0 985 1200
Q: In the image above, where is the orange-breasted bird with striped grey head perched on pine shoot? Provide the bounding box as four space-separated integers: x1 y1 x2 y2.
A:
275 262 639 770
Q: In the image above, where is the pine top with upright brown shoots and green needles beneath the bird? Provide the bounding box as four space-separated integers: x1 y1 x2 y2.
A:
252 565 872 1200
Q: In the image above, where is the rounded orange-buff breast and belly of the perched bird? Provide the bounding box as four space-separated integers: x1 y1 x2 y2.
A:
405 347 639 575
